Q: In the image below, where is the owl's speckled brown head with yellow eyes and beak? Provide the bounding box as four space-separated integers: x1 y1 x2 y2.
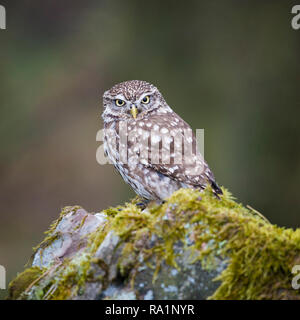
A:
102 80 165 122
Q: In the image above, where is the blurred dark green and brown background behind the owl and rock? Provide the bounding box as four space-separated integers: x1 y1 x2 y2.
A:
0 0 300 297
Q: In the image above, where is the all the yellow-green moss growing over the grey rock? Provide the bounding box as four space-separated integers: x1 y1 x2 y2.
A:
8 188 300 299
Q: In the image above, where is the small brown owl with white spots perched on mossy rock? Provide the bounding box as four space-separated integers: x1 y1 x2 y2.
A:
102 80 222 202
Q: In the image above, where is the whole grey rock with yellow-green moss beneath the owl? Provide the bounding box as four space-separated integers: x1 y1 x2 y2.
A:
9 189 300 299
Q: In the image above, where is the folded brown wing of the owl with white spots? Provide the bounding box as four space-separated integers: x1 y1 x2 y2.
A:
139 112 222 194
